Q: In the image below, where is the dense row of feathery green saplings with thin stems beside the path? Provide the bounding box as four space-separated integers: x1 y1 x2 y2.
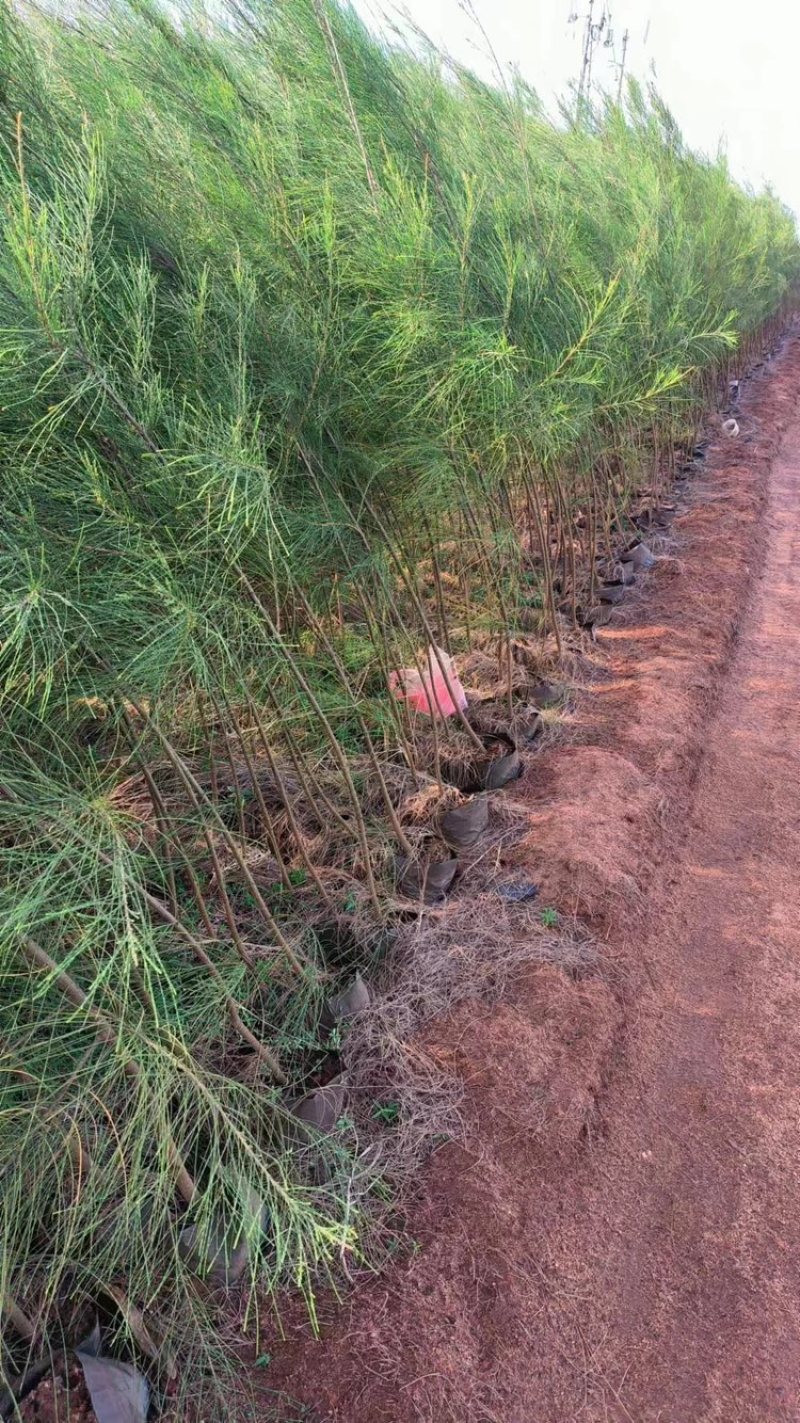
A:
0 0 799 1400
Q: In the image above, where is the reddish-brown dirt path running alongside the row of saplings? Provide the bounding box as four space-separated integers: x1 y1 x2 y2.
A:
265 332 800 1423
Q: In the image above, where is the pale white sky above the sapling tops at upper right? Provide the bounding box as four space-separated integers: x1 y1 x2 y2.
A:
356 0 800 215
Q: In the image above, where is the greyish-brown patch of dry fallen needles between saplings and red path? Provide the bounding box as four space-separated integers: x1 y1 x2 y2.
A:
333 848 598 1192
